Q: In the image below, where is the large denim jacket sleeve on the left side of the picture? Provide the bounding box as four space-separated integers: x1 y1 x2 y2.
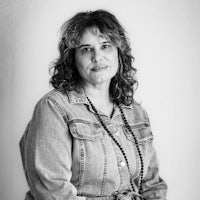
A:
24 99 85 200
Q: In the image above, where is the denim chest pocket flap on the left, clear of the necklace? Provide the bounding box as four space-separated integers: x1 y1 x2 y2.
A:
69 120 105 141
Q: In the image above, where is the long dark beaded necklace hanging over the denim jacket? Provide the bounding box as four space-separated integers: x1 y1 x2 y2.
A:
86 95 144 194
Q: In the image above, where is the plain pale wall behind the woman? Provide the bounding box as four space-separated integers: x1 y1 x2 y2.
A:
0 0 200 200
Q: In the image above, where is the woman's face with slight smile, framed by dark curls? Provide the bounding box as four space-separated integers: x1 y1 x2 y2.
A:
75 28 118 86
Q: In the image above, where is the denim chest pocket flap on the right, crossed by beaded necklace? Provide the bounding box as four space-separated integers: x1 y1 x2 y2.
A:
123 123 153 145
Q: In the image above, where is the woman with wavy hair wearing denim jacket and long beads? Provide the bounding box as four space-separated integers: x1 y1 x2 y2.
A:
20 10 167 200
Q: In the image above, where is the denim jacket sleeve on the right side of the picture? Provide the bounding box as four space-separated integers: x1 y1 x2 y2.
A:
142 147 167 200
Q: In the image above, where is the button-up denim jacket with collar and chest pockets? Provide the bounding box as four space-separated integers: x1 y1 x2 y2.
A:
20 90 167 200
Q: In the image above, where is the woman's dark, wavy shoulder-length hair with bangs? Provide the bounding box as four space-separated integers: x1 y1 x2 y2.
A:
50 10 138 105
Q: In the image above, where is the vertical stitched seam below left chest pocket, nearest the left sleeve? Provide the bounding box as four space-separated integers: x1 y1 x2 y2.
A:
77 140 85 195
